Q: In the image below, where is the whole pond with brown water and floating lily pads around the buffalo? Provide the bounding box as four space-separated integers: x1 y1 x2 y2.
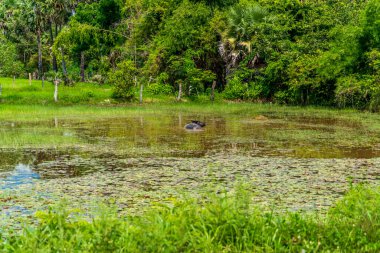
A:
0 112 380 226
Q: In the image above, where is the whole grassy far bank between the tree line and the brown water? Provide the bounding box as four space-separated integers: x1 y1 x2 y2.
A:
0 78 378 120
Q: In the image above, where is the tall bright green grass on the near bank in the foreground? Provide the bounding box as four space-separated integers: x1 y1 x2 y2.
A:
0 186 380 252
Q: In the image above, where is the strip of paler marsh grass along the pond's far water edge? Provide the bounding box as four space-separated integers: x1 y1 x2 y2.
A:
0 97 378 121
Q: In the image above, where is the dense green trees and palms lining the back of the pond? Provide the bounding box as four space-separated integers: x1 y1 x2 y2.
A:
0 0 380 107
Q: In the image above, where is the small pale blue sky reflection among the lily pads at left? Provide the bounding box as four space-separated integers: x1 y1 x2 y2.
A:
0 164 40 190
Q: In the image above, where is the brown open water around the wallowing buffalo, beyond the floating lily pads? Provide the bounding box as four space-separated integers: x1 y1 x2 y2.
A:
0 113 380 178
